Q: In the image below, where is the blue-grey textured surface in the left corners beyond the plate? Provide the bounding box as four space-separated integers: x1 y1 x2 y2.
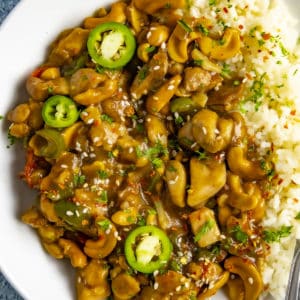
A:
0 0 23 300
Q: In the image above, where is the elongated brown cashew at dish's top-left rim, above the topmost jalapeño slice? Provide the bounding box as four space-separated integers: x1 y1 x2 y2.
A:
83 1 127 29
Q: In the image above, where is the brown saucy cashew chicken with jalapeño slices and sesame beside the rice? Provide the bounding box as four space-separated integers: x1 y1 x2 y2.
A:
7 0 300 300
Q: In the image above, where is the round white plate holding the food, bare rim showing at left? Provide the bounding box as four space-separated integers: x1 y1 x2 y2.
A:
0 0 300 300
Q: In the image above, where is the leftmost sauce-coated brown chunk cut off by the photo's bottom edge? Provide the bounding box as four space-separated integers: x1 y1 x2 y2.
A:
76 259 110 300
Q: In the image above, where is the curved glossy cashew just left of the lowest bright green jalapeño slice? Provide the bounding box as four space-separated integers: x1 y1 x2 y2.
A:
83 219 117 258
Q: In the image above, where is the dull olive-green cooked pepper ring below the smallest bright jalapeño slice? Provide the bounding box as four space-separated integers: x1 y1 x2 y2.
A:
29 128 66 159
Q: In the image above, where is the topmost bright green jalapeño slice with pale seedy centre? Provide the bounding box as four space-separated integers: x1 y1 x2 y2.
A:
87 22 136 69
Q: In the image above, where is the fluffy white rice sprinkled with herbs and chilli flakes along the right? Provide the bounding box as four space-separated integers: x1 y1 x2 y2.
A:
191 0 300 300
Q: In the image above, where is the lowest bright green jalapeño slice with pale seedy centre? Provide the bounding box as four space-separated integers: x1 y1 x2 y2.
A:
124 226 173 274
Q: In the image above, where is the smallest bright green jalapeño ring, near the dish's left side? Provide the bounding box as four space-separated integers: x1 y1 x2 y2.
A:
42 95 79 128
